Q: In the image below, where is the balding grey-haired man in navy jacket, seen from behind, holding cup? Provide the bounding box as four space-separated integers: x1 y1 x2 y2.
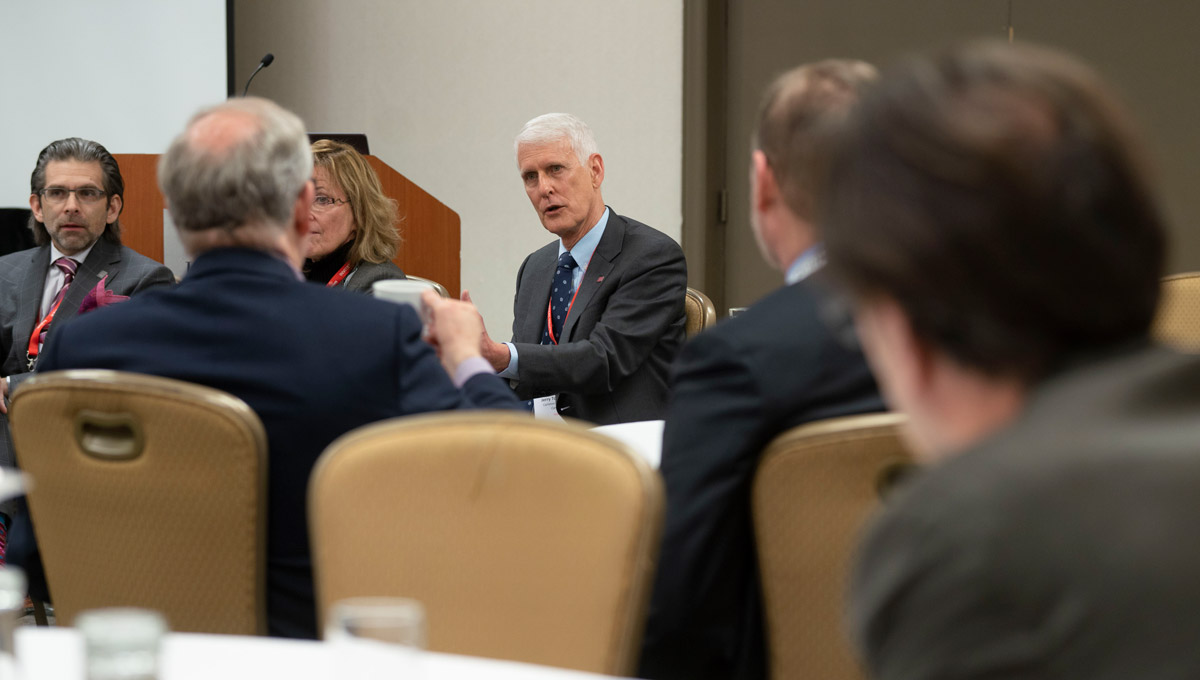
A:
17 98 521 638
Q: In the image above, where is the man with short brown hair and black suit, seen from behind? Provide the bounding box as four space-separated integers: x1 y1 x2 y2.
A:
641 60 883 679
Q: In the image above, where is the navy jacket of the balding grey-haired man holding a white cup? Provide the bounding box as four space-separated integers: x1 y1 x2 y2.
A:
25 249 522 638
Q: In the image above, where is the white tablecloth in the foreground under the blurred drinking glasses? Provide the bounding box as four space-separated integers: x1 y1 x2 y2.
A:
14 626 624 680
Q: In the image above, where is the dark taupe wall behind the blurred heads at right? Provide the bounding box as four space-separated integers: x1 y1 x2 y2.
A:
715 0 1200 306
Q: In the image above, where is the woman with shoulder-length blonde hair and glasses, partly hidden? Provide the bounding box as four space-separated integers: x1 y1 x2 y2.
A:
304 139 404 293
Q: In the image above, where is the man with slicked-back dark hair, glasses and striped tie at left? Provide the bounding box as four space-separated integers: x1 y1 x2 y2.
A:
0 137 174 555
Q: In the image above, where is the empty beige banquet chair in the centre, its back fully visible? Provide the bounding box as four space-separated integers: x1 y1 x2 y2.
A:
308 413 662 675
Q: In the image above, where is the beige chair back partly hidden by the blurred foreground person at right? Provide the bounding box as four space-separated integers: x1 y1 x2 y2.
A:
752 414 912 680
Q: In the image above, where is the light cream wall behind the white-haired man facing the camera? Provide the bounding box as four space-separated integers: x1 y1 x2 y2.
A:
234 0 683 339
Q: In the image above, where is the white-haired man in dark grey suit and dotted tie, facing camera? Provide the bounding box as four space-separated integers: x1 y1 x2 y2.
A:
463 113 688 425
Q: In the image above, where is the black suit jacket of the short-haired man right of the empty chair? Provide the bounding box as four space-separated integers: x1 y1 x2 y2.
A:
638 278 883 680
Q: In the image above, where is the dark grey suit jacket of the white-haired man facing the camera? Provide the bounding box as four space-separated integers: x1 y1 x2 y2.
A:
512 212 688 425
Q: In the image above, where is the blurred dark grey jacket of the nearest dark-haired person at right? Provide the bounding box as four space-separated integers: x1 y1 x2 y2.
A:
851 347 1200 680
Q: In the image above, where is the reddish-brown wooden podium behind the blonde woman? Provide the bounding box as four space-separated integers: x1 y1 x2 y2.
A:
113 154 462 297
